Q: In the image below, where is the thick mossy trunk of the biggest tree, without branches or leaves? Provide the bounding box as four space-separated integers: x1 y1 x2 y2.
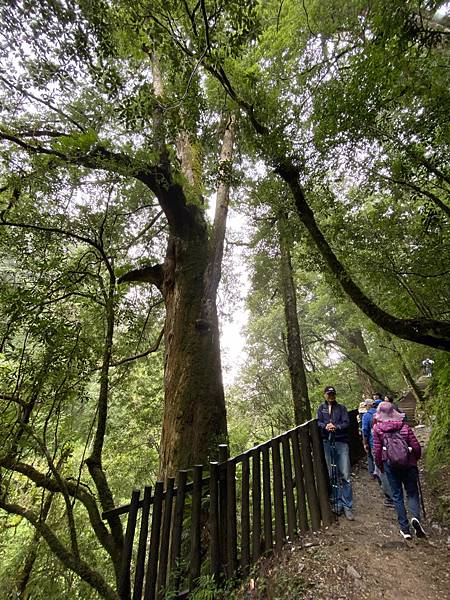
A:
160 117 235 478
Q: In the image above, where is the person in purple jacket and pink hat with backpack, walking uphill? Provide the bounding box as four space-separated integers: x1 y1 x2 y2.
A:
373 402 425 540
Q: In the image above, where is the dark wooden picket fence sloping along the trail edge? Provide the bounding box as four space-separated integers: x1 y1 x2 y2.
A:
103 412 364 600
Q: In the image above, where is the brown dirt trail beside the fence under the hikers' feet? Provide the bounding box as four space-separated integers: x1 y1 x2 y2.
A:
238 427 450 600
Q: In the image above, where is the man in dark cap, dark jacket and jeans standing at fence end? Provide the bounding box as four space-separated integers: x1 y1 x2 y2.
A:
317 386 354 521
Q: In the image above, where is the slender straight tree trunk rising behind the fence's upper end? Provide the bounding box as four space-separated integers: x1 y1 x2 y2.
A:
278 214 311 425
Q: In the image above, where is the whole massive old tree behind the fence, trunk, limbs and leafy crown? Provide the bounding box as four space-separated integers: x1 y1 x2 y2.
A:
0 3 246 476
